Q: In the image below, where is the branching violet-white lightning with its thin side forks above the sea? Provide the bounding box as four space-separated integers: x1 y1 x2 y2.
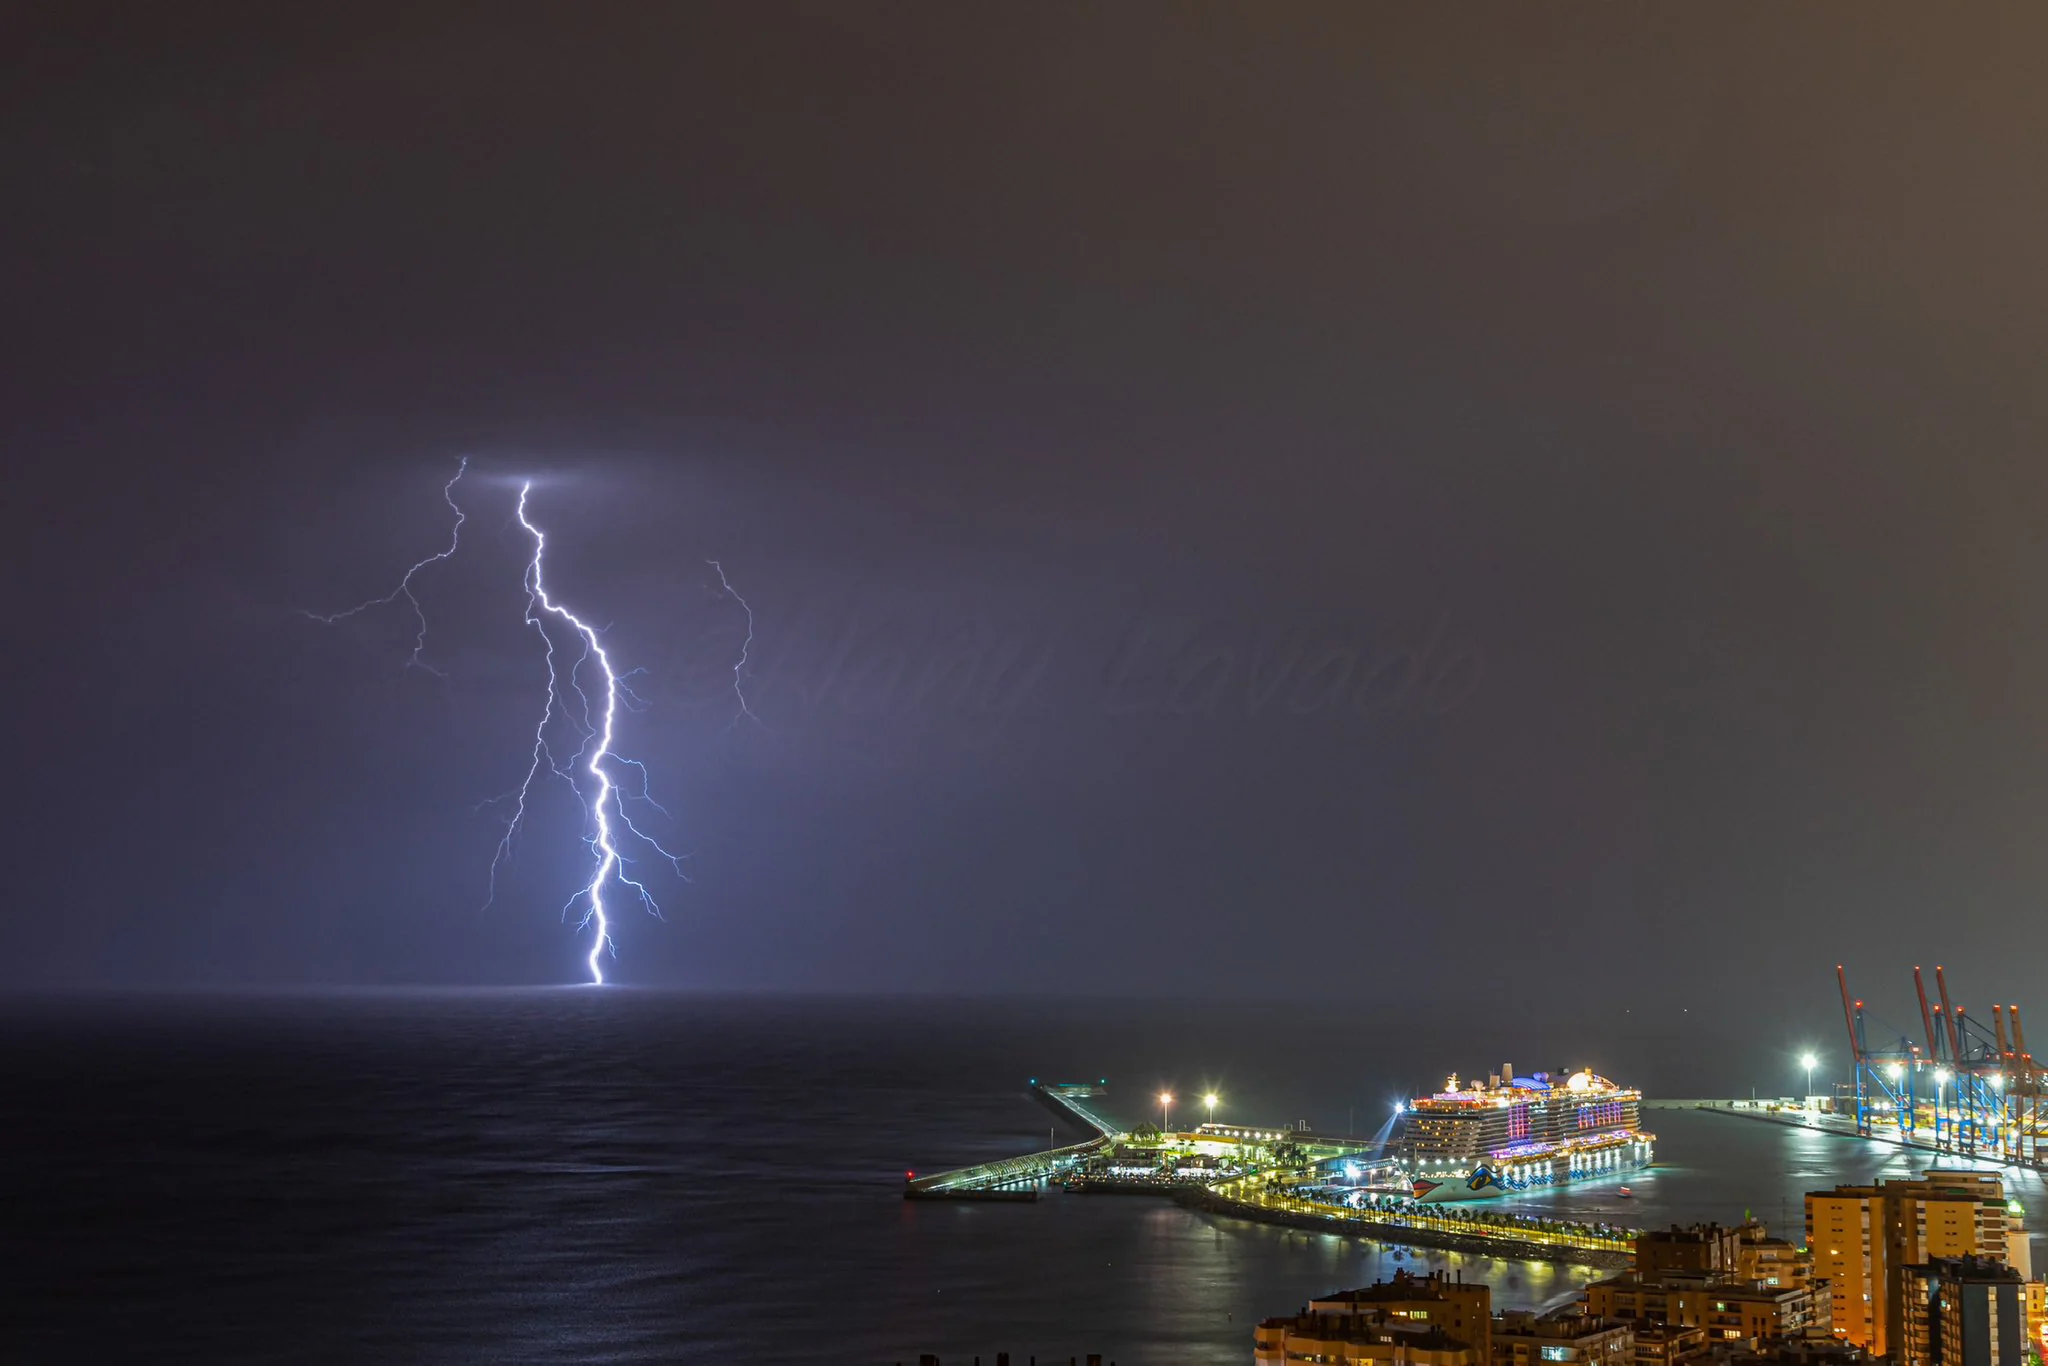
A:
301 457 760 985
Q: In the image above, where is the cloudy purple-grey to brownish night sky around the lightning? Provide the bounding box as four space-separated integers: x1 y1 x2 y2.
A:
12 4 2048 1022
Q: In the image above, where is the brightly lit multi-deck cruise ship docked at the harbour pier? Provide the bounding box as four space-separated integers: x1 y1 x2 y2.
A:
1391 1067 1655 1202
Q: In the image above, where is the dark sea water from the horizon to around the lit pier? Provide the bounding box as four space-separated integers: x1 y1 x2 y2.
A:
0 989 2042 1366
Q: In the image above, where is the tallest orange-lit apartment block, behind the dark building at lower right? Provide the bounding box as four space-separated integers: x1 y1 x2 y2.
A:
1806 1169 2007 1356
